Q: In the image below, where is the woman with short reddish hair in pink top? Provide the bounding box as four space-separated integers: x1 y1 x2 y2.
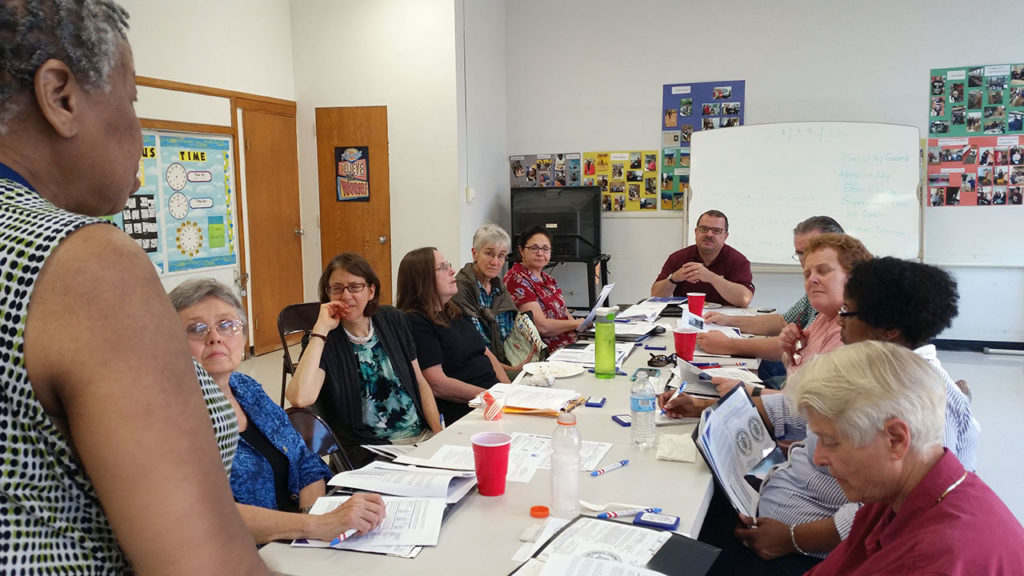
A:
779 234 871 374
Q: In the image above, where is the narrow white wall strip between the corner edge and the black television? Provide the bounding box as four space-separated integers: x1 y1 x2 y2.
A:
454 0 510 264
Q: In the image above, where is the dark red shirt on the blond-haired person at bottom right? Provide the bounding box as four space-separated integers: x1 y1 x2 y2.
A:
807 449 1024 576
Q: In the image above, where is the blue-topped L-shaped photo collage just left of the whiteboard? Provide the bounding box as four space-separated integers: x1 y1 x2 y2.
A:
659 80 745 210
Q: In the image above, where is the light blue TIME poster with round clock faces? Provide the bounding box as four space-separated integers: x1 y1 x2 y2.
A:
158 133 238 272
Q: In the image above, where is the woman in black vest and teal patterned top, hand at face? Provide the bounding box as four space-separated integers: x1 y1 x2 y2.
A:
286 252 441 446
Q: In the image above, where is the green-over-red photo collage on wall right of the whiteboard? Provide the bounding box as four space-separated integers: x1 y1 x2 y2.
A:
925 64 1024 207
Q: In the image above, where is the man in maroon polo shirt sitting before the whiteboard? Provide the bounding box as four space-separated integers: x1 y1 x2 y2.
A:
650 210 754 307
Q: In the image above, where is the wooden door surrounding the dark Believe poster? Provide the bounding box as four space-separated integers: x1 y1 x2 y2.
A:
316 106 391 304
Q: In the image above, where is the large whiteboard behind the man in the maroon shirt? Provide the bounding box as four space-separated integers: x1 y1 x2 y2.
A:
689 122 921 264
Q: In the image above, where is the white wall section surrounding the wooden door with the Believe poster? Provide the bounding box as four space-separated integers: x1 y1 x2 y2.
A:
291 0 461 299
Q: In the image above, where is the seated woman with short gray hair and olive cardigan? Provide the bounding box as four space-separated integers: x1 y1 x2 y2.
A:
452 223 518 366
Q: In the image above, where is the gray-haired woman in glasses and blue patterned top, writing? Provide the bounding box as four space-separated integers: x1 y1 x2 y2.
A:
170 279 384 543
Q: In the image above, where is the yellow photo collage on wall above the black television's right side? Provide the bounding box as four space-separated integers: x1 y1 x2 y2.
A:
583 150 657 212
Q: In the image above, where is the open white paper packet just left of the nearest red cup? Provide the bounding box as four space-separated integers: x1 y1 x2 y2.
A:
328 461 476 503
